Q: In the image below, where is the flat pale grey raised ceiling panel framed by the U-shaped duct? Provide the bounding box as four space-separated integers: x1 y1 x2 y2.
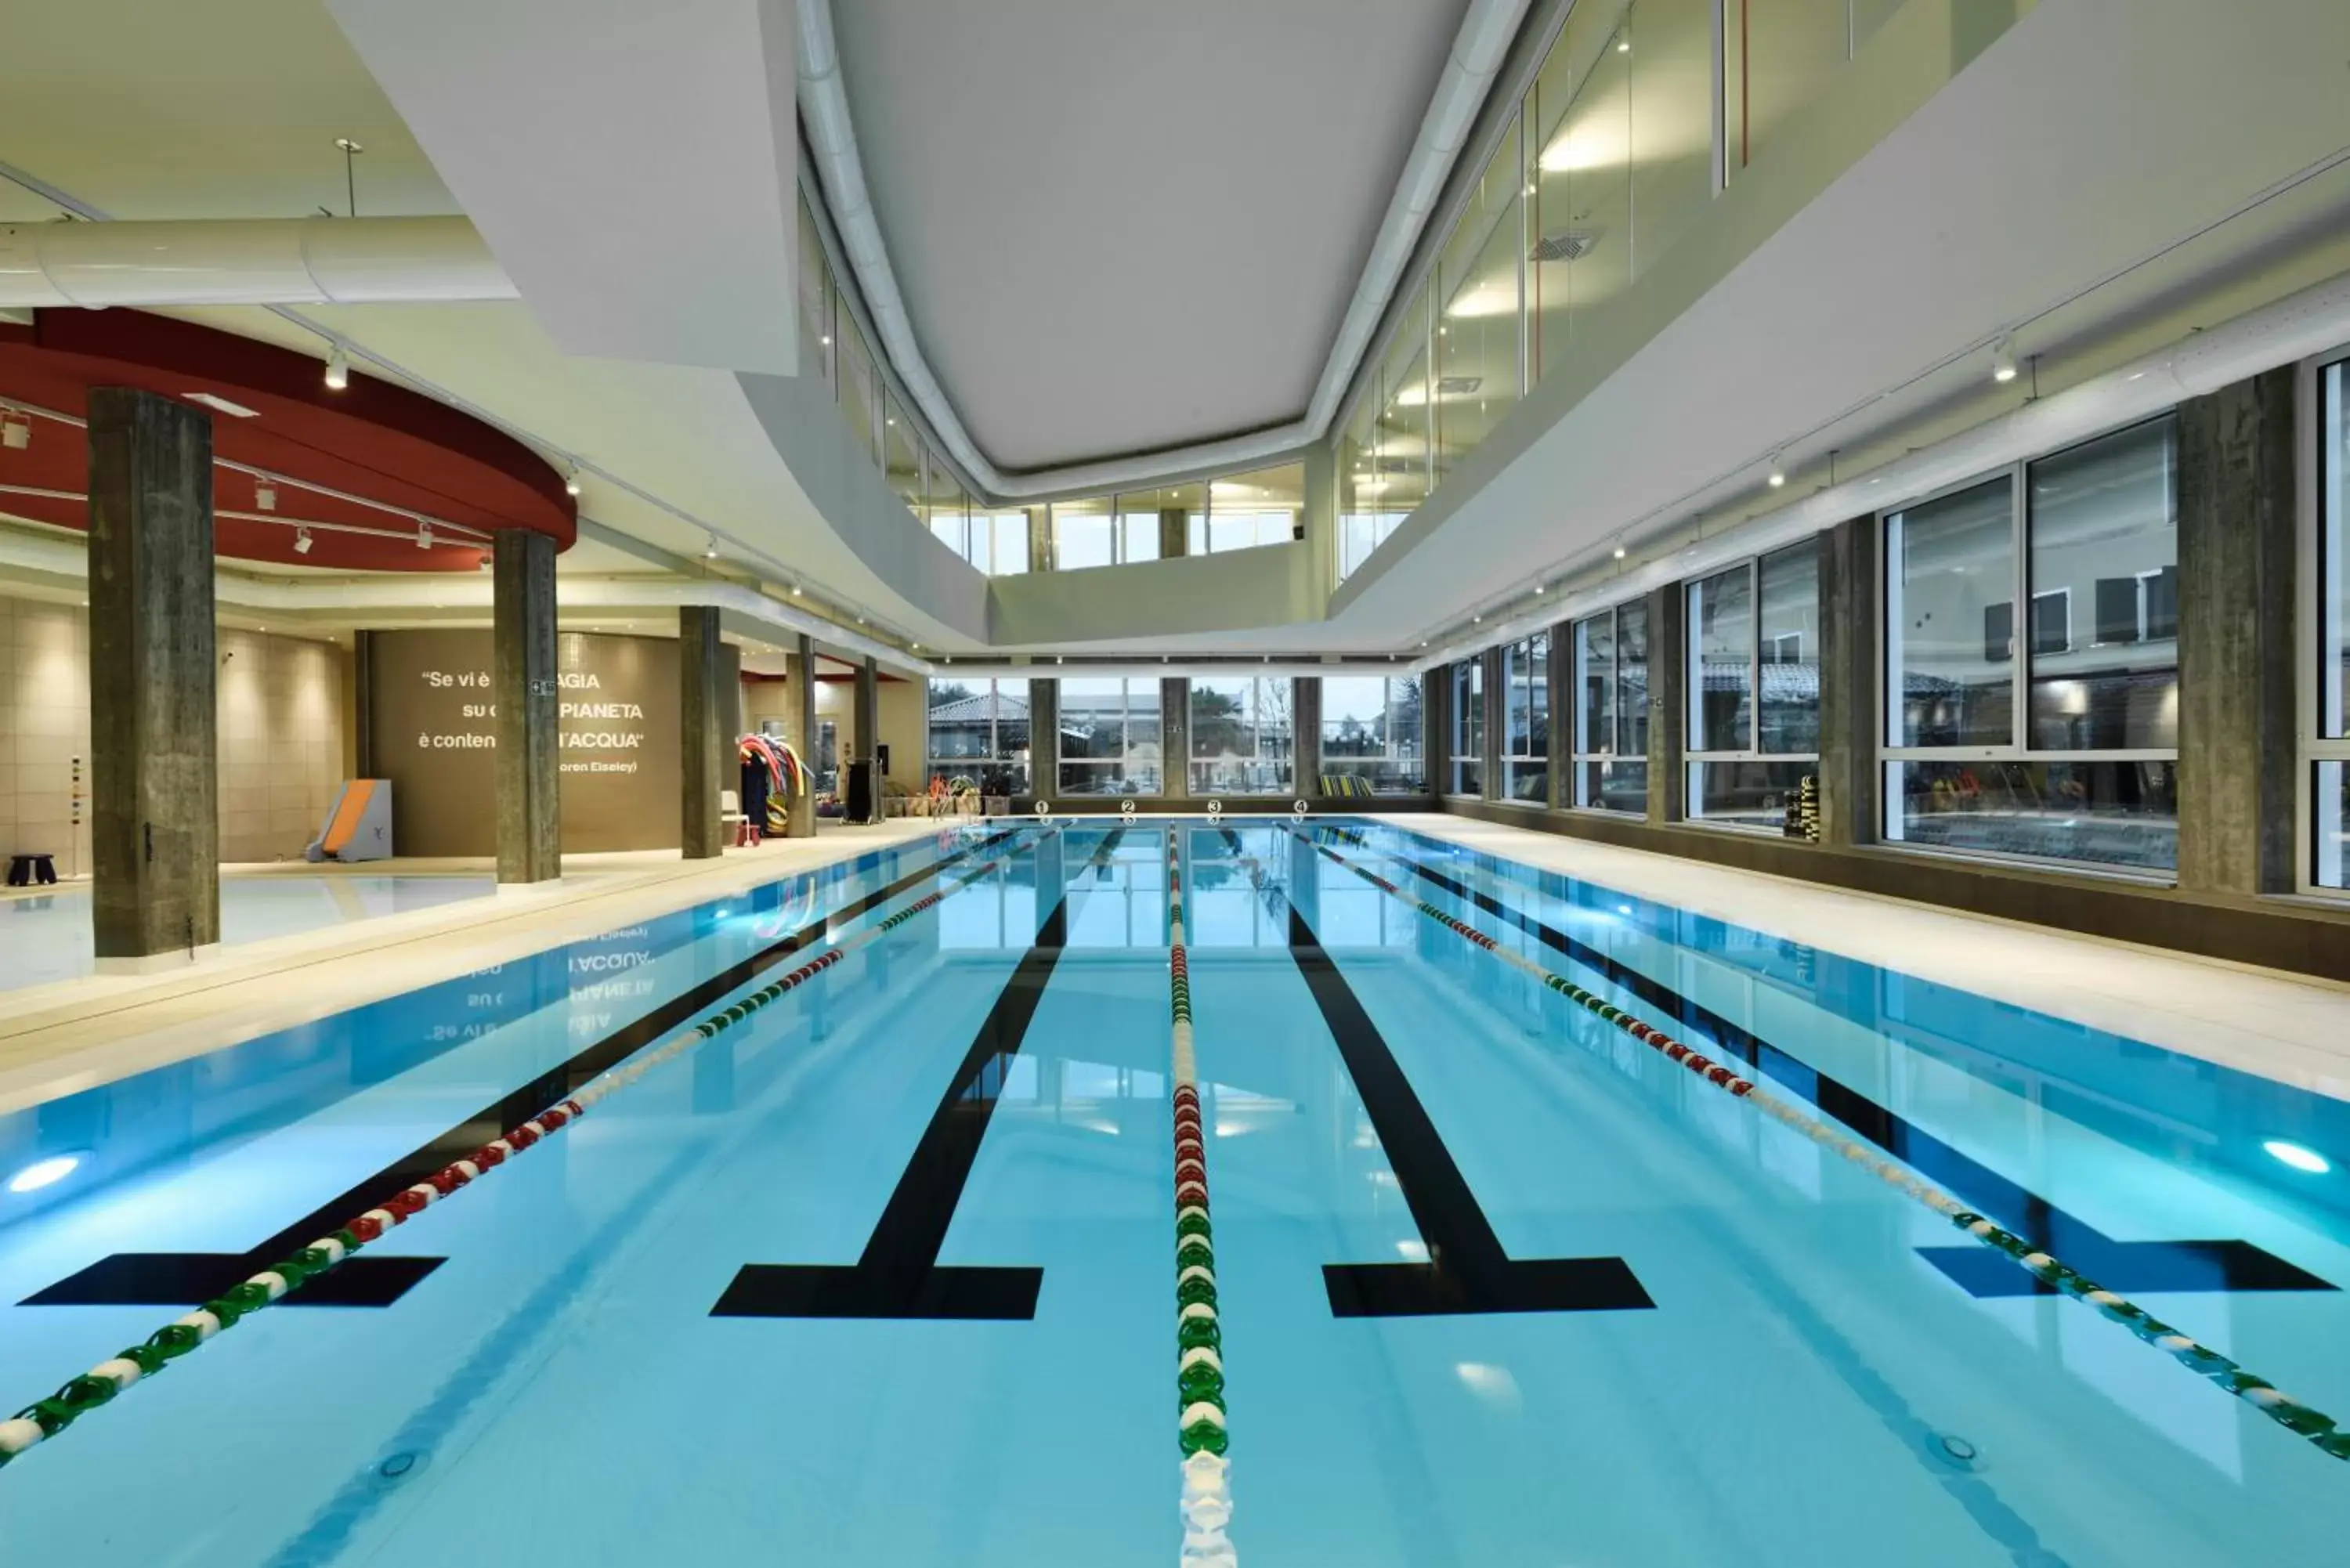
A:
834 0 1466 470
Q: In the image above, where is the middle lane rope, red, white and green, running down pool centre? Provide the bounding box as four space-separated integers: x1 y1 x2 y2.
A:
1168 828 1241 1568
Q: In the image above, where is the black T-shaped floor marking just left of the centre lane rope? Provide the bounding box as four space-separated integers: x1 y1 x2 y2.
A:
710 828 1126 1321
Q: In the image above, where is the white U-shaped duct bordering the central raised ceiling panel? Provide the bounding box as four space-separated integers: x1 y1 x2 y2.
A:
799 0 1530 500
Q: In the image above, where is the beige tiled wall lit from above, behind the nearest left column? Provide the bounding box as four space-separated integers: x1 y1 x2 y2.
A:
0 597 350 877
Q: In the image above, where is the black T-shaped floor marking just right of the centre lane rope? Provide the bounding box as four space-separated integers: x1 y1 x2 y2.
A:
1290 879 1657 1317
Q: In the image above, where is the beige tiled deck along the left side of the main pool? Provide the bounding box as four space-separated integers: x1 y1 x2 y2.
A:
0 821 938 1115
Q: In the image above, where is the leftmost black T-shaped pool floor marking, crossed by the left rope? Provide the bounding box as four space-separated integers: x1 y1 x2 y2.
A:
19 828 1018 1307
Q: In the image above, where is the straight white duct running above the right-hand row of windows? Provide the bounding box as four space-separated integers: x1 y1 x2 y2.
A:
1412 275 2350 674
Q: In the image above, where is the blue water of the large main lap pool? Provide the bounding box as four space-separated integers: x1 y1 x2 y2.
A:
0 818 2350 1568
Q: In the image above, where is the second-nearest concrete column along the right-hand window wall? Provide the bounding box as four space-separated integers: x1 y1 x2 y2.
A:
1819 515 1885 849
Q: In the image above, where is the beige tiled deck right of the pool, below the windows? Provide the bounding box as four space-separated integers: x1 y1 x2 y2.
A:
1377 816 2350 1100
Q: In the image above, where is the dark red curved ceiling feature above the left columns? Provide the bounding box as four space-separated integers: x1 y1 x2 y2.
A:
0 310 578 571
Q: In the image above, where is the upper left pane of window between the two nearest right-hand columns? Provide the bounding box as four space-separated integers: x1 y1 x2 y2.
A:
1885 475 2016 745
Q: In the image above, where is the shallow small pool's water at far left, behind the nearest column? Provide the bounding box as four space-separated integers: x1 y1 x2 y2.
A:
0 873 498 990
